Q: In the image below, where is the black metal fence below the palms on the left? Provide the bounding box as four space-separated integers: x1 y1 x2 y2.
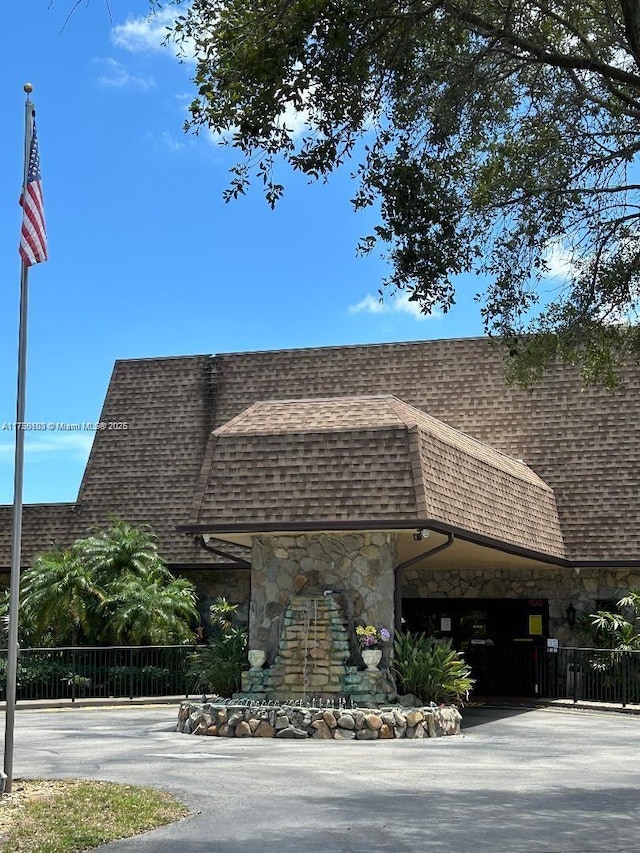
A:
0 646 194 701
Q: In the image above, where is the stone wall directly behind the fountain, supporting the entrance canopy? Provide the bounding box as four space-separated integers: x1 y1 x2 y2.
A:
249 532 396 663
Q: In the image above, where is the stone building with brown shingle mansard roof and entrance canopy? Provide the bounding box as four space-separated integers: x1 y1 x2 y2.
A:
0 338 640 693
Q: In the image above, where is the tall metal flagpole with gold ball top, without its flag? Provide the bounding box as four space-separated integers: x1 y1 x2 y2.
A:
3 83 34 793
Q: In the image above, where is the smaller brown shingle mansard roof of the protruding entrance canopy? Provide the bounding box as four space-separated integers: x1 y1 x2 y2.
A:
193 395 564 556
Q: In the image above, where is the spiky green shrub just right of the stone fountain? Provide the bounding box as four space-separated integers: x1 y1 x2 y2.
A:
392 633 475 704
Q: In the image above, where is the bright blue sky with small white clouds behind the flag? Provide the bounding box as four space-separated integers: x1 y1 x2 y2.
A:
0 0 482 503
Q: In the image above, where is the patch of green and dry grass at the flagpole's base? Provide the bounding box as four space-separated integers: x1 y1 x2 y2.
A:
0 779 188 853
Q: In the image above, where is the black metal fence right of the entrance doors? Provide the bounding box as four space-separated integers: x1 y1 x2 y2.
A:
465 645 640 706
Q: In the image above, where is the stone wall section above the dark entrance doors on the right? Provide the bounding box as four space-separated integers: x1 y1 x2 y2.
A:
401 566 640 646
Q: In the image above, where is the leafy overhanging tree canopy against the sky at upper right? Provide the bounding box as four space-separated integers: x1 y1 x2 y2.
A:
166 0 640 382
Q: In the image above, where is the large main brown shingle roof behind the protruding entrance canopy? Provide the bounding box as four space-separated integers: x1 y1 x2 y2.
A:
0 338 640 566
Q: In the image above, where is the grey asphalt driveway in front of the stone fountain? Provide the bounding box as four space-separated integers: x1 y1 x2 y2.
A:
5 706 640 853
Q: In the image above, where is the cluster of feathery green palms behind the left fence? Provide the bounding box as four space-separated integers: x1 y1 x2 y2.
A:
14 520 198 645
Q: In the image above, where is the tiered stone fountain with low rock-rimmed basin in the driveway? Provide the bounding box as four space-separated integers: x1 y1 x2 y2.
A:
177 589 461 740
